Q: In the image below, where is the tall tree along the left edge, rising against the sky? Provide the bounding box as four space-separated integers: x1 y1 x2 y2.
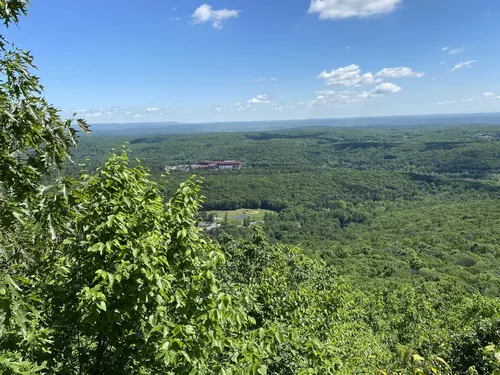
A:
0 0 79 374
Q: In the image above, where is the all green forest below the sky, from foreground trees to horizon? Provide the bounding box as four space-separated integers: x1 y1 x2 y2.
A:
0 0 500 375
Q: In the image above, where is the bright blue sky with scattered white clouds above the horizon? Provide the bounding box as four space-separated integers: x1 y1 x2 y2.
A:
6 0 500 123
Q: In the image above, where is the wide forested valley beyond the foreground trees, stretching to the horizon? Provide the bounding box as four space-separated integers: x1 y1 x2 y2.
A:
71 125 500 296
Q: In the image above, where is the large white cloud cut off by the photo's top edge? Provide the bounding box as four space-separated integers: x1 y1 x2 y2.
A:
309 0 402 20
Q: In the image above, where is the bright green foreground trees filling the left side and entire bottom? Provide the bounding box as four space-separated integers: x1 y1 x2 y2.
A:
0 0 500 375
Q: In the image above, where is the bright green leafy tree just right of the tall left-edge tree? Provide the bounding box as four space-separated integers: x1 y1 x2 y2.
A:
30 153 262 374
